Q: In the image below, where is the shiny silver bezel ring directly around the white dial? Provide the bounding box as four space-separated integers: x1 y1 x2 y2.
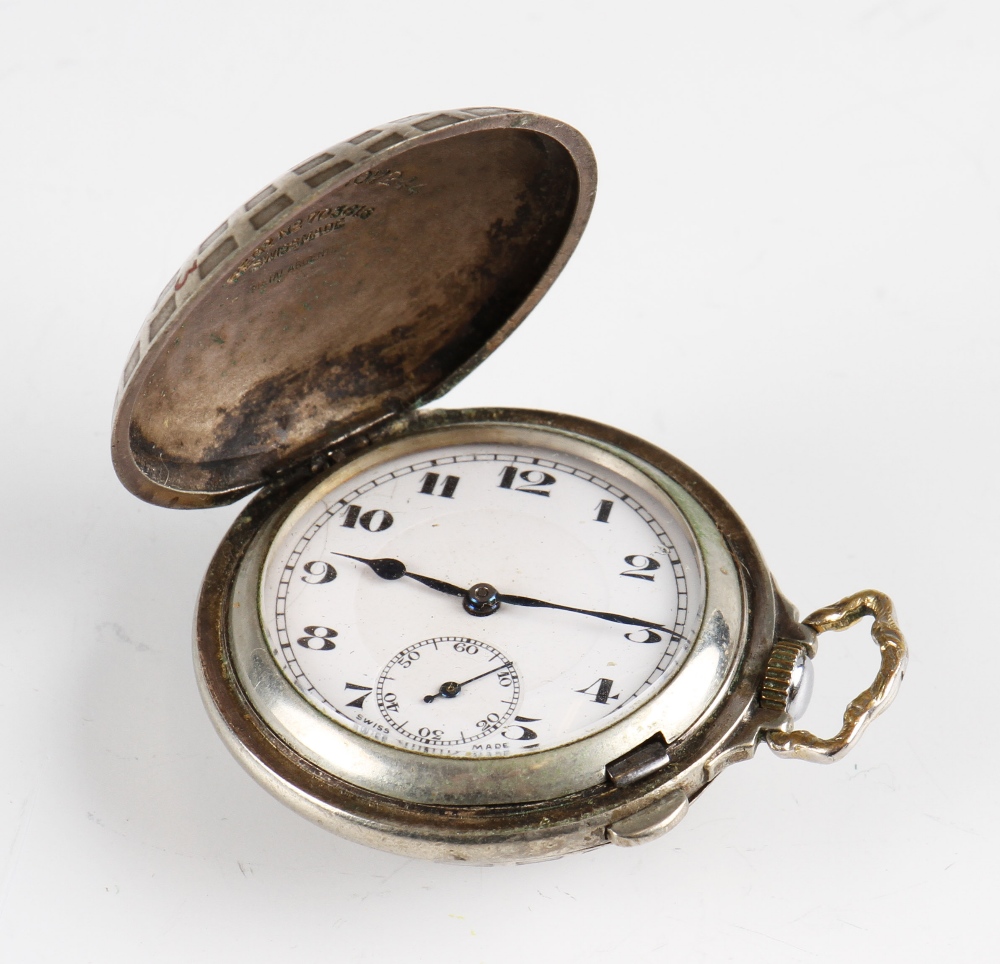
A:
230 420 742 805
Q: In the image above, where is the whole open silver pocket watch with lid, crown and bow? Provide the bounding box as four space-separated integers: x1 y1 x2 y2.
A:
112 108 906 863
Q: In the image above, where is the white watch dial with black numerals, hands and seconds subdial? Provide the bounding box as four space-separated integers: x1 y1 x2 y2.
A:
260 431 704 757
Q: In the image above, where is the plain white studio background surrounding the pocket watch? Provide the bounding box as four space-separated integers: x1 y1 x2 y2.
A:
0 0 1000 964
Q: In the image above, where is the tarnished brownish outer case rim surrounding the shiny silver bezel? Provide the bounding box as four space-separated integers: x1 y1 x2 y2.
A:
195 409 794 863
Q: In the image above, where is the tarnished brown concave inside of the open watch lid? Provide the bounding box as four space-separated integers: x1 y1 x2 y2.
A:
130 129 578 492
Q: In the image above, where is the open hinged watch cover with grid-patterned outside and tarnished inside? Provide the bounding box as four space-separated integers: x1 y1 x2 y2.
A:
112 108 596 508
